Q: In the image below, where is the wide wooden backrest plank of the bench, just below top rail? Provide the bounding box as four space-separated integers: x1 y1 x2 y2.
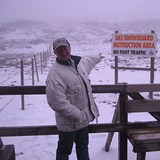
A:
126 100 160 112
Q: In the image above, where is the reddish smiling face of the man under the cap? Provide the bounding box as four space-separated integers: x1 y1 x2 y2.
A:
55 46 71 61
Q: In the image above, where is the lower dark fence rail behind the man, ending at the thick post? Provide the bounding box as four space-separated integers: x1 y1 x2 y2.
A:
0 123 124 137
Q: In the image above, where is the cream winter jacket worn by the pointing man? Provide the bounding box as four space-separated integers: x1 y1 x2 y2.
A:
46 55 101 132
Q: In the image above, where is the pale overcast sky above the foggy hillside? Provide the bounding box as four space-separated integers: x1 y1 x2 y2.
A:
0 0 160 22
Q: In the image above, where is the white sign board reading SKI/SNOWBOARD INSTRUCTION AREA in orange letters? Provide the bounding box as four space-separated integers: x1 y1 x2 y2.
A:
112 33 157 57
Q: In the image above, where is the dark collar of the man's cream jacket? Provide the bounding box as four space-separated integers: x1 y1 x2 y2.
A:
56 55 81 66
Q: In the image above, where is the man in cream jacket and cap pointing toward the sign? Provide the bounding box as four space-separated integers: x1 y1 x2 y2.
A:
46 38 103 160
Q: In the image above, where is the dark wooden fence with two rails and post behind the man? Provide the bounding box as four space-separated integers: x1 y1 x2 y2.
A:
0 84 160 160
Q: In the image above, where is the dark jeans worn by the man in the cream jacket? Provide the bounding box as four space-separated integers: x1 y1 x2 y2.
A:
56 127 90 160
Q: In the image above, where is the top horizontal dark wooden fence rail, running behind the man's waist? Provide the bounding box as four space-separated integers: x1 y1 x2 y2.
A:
0 83 160 95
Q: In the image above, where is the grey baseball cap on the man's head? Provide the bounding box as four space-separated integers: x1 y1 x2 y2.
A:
53 38 70 52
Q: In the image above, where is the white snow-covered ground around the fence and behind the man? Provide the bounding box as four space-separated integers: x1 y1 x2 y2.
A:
0 20 160 160
